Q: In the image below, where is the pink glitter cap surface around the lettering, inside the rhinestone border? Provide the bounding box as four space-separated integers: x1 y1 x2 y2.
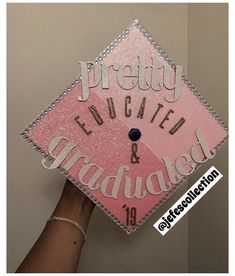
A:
23 21 227 233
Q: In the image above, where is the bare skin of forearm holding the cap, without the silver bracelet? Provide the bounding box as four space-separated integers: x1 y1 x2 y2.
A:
16 180 94 273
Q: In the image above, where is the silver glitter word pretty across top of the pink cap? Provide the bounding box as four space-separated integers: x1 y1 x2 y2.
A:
77 56 182 102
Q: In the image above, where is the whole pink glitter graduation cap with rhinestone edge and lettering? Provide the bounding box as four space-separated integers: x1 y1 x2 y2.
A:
22 20 227 233
